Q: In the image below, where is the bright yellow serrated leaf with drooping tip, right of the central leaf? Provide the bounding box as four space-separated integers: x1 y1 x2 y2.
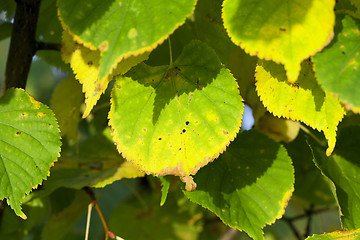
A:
255 61 345 155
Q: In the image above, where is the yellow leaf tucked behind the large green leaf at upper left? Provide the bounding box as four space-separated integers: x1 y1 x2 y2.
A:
61 31 149 118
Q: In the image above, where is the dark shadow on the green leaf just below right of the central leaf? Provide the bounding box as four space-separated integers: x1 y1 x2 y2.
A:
194 130 280 198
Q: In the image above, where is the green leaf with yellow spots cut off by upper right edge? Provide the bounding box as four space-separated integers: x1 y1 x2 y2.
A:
313 15 360 113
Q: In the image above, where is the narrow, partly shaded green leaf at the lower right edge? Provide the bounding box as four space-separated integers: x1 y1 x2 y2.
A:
311 126 360 230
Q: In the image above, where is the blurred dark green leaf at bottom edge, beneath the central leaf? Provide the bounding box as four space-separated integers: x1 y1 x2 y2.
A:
109 190 202 240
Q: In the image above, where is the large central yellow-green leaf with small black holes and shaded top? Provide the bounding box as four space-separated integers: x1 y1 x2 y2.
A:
109 41 243 176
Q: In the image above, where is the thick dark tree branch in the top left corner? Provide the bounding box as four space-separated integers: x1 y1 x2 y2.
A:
2 0 41 93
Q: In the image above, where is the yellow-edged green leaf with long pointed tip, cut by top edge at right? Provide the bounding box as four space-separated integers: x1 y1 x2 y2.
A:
223 0 335 82
